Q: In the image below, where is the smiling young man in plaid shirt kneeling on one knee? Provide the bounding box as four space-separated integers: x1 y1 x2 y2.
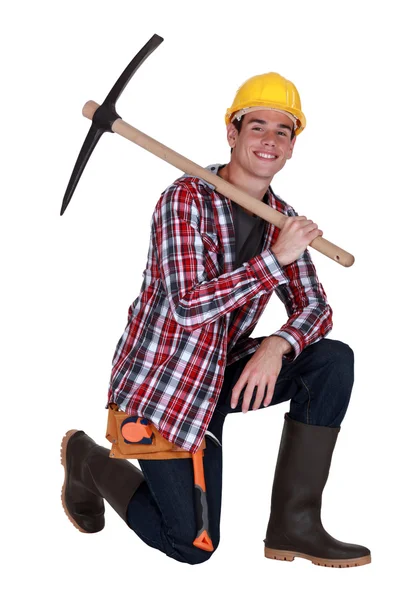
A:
62 73 370 567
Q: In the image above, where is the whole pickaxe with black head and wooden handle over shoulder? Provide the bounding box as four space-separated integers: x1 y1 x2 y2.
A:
61 34 354 267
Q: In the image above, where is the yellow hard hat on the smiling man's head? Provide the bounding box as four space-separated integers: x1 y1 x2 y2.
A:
225 73 306 135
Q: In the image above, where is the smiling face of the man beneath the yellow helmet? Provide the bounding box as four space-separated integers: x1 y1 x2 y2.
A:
227 109 296 178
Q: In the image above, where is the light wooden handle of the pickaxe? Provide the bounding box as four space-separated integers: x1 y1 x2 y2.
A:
82 100 354 267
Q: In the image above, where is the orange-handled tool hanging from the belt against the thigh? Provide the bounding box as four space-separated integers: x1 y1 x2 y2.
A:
192 450 214 552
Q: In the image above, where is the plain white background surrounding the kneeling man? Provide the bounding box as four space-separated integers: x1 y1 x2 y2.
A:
0 0 400 600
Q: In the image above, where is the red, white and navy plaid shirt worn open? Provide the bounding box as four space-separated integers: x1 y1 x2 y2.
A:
108 165 332 452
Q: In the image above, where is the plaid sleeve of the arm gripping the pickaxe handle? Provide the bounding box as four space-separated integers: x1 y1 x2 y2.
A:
153 183 289 331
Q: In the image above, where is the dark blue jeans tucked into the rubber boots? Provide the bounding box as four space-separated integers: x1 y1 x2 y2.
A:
127 337 354 565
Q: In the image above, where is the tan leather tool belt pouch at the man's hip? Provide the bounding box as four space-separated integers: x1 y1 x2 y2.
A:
106 403 206 460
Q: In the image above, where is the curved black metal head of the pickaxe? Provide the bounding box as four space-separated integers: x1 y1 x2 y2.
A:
60 34 164 215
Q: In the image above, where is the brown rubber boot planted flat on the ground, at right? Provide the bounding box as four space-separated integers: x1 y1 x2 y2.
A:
264 414 371 567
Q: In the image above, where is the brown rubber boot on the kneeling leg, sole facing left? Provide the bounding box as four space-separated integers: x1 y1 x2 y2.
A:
61 429 144 533
